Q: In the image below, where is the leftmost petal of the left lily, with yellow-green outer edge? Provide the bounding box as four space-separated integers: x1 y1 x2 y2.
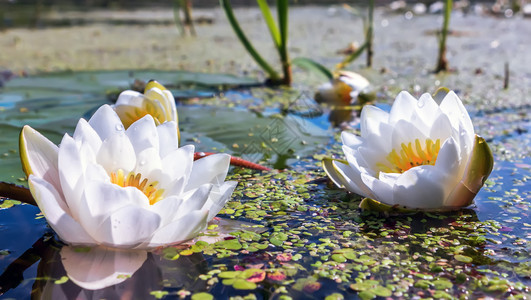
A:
20 125 61 190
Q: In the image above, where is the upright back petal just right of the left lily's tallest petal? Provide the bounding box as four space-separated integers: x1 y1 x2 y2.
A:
125 115 159 154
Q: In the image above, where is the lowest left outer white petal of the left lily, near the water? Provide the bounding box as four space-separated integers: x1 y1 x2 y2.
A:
28 175 96 245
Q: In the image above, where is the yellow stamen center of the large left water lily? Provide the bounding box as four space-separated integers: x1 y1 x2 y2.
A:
111 169 164 205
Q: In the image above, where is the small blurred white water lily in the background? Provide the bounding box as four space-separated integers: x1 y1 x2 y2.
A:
315 71 369 105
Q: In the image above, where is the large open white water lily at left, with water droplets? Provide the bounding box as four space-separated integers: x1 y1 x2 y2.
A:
20 105 236 249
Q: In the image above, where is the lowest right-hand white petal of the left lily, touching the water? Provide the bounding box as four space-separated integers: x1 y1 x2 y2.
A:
141 210 208 249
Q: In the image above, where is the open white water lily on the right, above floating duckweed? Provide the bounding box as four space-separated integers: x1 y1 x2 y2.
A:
323 92 493 209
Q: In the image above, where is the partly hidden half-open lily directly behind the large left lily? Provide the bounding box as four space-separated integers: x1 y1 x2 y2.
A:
114 80 179 142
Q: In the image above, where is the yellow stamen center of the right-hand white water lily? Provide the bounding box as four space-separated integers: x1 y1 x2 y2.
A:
376 139 441 173
